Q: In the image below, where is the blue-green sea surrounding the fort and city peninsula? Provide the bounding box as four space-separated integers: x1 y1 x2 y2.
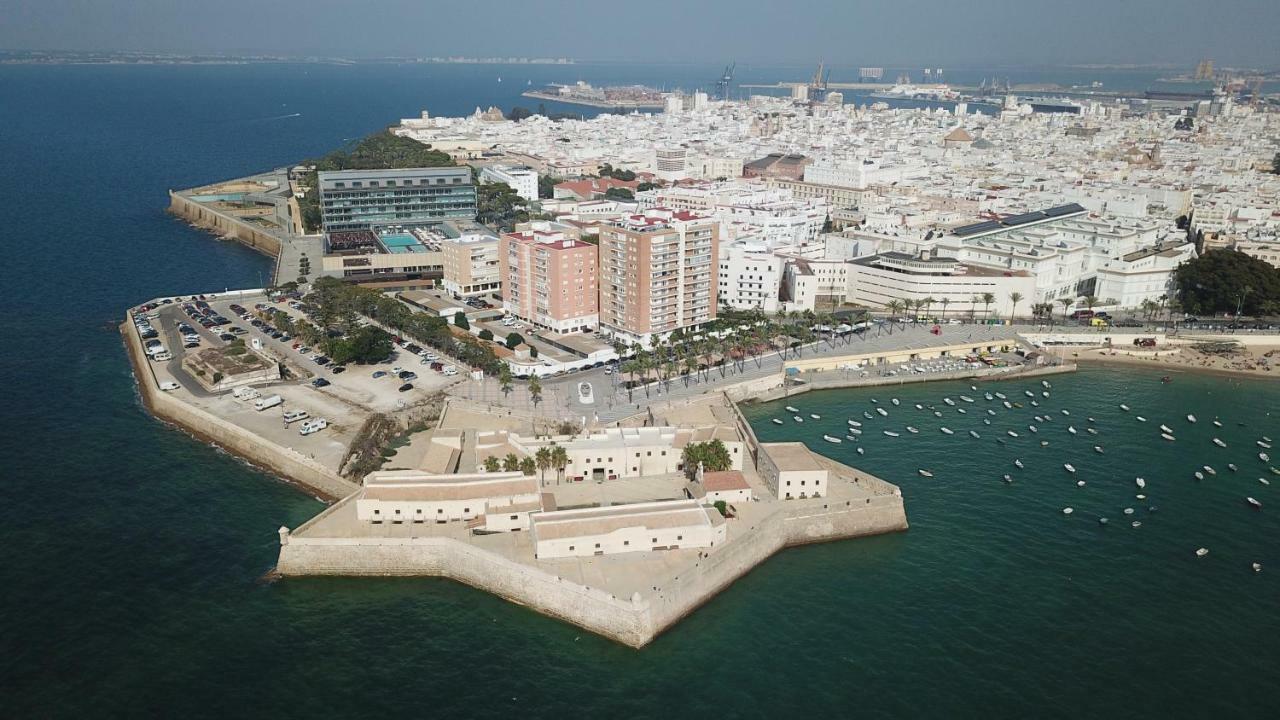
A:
0 64 1280 719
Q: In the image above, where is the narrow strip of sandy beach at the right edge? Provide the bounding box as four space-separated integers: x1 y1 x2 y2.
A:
1055 341 1280 378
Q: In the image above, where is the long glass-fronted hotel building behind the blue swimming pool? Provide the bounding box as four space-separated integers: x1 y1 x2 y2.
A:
319 168 476 233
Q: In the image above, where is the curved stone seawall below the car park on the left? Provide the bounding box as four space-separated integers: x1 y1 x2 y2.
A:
120 320 360 500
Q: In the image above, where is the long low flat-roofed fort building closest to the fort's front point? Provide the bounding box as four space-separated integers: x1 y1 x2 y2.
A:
531 500 728 560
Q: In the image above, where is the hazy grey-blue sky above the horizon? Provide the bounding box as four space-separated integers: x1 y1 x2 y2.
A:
0 0 1280 68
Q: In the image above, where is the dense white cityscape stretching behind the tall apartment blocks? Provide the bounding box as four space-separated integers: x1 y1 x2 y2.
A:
394 92 1280 333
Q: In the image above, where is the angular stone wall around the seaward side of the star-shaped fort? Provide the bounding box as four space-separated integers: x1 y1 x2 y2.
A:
276 493 908 647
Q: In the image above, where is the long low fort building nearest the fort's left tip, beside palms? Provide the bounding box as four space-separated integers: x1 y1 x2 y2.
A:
356 470 543 532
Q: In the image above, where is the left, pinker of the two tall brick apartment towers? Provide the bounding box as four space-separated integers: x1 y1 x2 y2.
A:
498 229 599 333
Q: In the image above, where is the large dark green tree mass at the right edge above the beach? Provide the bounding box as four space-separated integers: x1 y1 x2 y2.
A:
1174 250 1280 315
